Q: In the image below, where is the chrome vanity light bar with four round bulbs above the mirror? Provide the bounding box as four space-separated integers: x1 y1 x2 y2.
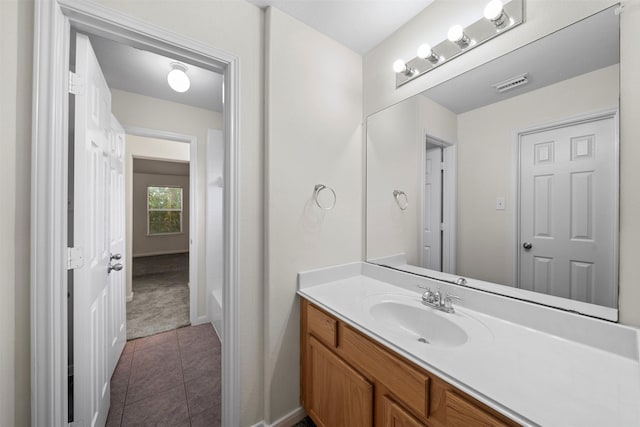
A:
393 0 525 88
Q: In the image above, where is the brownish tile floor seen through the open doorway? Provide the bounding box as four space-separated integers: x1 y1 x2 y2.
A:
107 324 221 427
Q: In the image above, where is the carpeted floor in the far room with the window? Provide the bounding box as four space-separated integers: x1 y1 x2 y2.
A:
127 254 190 340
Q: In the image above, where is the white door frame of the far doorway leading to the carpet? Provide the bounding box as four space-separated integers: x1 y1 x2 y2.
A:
124 126 202 325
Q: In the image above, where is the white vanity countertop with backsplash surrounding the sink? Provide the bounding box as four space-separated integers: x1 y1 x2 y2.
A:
298 263 640 427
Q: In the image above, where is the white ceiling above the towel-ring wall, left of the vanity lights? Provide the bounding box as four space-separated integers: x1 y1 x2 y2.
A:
248 0 433 55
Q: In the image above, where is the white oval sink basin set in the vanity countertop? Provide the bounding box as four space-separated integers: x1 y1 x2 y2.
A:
366 294 492 348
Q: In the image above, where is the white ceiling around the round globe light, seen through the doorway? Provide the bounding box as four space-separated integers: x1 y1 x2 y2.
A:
89 35 222 113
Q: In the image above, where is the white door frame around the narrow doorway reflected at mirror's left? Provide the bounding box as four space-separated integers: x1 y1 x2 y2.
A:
418 133 458 274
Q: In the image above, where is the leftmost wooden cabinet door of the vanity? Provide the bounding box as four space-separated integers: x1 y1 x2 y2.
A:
305 336 373 427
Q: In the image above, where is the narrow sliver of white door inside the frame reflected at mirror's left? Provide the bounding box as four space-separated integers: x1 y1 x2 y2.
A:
422 142 442 271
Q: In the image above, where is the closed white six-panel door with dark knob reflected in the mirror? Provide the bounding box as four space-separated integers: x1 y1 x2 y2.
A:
518 117 617 307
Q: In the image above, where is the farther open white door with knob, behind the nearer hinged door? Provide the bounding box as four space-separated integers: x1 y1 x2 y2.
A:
108 115 128 373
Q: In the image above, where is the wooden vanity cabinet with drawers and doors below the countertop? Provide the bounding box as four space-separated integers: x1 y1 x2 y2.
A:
300 298 518 427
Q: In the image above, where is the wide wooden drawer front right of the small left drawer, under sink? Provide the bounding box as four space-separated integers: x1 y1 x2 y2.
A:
340 326 429 417
